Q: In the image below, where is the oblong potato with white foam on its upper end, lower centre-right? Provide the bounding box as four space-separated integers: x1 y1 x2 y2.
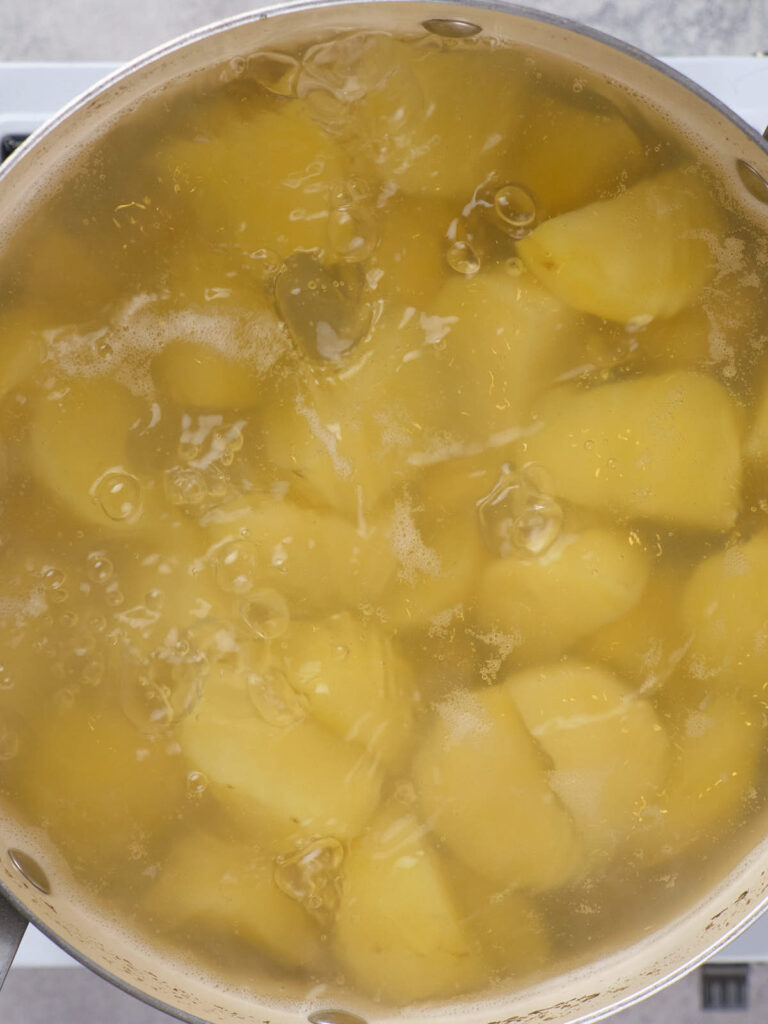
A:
414 686 583 889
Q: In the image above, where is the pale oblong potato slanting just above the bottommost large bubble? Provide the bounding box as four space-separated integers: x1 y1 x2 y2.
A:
177 665 381 841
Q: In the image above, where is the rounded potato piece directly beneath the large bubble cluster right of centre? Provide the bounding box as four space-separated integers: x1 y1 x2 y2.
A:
477 527 648 660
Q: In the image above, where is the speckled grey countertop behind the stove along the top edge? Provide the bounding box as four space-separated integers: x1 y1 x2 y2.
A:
0 0 768 60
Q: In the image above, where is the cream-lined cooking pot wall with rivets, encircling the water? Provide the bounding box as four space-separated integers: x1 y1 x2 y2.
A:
0 6 768 1024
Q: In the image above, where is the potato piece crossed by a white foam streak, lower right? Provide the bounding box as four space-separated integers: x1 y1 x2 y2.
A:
503 659 670 858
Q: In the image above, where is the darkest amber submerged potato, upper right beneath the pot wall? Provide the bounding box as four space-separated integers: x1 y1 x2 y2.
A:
509 94 644 219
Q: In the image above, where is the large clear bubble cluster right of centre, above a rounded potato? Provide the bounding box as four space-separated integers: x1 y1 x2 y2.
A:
477 463 563 558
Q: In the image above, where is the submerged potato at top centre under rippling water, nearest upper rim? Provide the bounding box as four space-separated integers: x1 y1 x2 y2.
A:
353 50 523 202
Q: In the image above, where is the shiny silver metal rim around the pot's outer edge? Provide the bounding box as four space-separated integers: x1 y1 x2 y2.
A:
0 0 768 1024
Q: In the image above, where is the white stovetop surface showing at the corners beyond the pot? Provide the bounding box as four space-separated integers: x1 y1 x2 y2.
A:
0 56 768 967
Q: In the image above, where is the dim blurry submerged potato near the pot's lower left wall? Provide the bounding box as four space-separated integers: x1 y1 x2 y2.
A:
20 699 186 870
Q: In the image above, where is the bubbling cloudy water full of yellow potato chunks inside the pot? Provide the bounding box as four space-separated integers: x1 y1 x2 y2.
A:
0 24 768 1005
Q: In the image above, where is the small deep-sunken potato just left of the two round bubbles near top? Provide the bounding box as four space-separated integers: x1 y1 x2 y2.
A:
366 197 456 309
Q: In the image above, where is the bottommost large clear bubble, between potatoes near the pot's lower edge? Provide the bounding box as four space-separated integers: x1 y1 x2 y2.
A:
274 837 344 923
